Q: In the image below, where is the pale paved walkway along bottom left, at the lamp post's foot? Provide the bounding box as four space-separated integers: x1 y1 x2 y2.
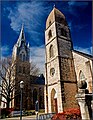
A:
1 115 36 120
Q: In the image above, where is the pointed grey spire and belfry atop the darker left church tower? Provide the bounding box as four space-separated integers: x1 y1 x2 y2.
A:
12 25 30 62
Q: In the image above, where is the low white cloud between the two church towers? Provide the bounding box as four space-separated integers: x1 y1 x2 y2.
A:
30 46 45 74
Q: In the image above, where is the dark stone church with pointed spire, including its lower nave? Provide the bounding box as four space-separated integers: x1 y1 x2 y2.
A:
1 26 45 110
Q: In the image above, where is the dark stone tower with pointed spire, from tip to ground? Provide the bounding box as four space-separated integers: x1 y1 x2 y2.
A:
12 26 30 109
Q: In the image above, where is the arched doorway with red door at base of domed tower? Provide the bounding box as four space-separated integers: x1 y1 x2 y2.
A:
51 88 58 113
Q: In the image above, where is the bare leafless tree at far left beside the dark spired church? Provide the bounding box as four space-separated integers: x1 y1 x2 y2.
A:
0 58 18 108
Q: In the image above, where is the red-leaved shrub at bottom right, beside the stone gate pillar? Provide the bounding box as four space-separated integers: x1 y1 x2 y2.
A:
52 108 81 120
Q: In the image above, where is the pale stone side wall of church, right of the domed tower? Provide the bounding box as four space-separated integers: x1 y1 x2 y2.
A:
73 51 93 93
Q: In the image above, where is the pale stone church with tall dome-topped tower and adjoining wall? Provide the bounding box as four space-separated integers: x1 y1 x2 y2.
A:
44 7 93 113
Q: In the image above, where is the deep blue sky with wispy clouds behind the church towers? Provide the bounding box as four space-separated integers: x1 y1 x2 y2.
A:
0 0 92 72
